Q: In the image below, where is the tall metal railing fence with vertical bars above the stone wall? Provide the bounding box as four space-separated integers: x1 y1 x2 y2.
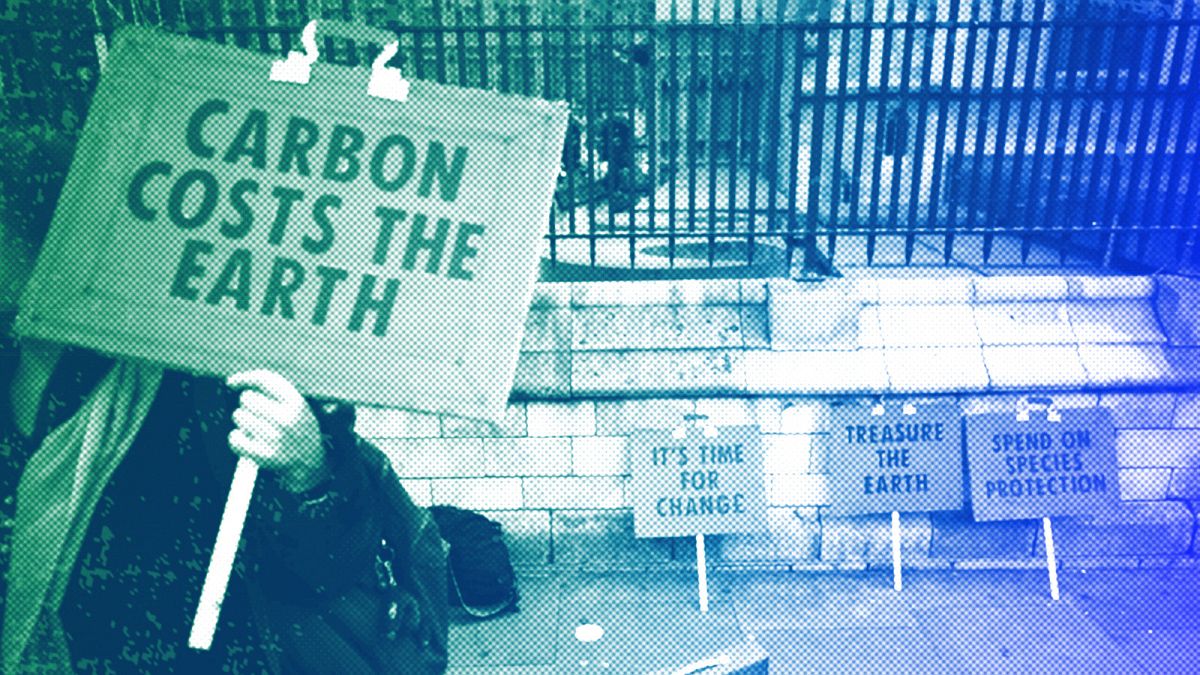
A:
0 0 1200 271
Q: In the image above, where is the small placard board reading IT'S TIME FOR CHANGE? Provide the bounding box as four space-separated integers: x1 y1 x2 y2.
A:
629 426 767 537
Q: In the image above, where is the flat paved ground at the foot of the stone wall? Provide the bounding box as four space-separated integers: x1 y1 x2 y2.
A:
450 568 1200 675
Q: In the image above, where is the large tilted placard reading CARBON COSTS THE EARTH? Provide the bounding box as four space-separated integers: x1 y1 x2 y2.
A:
18 28 568 419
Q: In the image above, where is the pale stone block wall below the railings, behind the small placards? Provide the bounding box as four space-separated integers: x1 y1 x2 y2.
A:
358 271 1200 568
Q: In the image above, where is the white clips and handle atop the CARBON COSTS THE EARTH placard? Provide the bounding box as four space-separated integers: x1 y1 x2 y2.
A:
270 19 409 102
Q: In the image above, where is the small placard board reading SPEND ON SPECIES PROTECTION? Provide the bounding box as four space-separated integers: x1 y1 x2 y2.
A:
967 408 1120 520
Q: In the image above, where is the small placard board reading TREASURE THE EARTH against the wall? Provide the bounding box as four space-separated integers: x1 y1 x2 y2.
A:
828 405 962 515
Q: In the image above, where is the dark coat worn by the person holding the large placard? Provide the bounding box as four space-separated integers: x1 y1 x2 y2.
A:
0 329 448 675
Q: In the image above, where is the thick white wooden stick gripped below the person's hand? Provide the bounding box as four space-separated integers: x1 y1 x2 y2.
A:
187 458 258 650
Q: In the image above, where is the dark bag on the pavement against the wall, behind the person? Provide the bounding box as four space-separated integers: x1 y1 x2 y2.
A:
430 506 520 619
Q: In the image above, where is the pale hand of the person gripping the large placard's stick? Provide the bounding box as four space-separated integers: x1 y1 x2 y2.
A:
226 370 329 492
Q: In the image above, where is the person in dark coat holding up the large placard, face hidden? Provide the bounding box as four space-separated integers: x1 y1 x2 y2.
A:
0 201 448 674
